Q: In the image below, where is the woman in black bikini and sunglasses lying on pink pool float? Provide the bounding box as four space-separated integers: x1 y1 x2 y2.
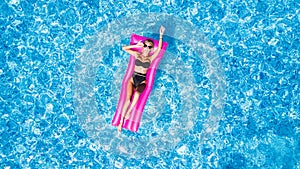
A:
118 26 165 132
